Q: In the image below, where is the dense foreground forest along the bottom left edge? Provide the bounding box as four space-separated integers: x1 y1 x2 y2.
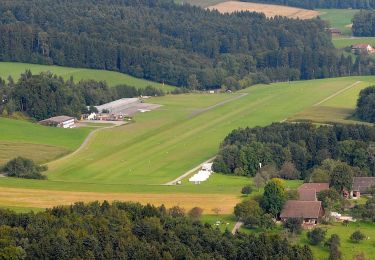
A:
0 201 313 260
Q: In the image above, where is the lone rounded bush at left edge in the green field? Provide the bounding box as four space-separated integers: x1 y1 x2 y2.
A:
2 157 47 179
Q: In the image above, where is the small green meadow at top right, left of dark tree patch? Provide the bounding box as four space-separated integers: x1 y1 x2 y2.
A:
318 9 359 36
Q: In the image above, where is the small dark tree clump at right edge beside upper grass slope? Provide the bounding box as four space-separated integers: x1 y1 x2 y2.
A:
355 86 375 123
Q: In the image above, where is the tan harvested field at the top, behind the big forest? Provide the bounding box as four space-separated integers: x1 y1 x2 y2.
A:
207 1 319 19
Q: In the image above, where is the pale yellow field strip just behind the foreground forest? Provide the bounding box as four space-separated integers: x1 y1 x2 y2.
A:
0 186 240 214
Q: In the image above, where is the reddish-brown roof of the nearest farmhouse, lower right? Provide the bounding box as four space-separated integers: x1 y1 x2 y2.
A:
280 200 322 218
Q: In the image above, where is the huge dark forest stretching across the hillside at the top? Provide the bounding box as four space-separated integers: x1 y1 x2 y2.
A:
0 0 375 89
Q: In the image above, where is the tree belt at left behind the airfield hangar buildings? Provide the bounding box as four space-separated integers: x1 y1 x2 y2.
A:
0 71 164 120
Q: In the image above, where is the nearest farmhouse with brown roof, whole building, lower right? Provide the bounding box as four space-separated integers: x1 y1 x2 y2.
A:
280 200 324 228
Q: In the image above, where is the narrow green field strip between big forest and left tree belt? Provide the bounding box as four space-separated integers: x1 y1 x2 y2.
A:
0 62 175 91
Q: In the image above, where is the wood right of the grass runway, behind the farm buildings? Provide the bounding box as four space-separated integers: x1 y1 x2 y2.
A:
214 123 375 179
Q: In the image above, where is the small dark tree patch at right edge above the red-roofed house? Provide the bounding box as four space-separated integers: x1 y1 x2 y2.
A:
352 10 375 37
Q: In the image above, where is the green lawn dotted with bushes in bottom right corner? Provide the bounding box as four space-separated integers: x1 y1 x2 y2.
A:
300 222 375 260
